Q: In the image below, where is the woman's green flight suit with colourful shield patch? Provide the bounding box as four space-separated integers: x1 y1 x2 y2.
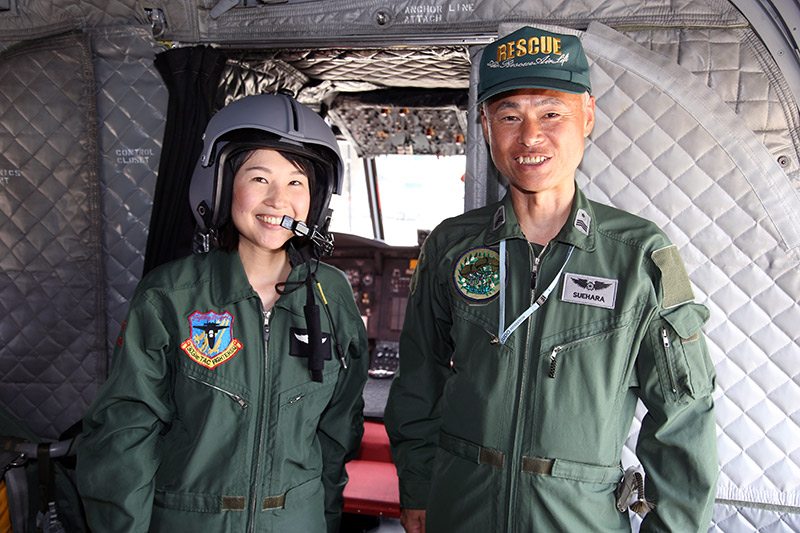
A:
77 250 369 533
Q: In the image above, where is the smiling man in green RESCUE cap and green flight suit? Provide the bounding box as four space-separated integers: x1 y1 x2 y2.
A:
386 27 717 533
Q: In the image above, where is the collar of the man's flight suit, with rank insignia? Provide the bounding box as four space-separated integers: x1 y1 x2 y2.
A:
484 185 595 252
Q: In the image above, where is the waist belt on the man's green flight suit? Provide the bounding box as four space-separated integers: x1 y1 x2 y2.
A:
439 431 622 483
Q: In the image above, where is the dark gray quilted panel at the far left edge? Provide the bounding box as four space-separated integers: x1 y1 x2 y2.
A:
0 33 107 438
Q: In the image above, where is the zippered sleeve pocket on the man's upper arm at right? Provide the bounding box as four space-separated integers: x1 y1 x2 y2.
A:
650 303 716 403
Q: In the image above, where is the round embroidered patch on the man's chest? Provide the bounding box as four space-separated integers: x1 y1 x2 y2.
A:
453 247 500 303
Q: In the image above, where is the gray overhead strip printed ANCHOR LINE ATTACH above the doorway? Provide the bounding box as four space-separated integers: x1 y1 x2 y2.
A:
180 0 746 42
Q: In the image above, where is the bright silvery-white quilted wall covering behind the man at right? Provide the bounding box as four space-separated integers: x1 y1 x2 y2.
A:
470 20 800 532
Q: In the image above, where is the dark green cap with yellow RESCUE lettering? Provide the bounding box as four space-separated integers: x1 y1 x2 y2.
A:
478 26 592 103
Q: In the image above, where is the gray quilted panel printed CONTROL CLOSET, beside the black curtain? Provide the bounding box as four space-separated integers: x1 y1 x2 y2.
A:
92 26 169 354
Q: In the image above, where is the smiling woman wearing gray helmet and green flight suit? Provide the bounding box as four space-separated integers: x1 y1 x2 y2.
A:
78 95 368 533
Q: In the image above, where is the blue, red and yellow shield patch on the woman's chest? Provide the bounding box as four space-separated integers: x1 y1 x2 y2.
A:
181 311 242 368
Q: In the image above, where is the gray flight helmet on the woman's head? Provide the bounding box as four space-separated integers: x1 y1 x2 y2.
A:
189 94 344 245
